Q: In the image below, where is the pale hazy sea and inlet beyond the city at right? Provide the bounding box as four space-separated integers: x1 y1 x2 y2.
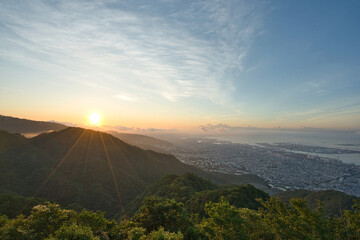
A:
211 129 360 165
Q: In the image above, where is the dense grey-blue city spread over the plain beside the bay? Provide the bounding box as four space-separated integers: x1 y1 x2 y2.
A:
168 138 360 196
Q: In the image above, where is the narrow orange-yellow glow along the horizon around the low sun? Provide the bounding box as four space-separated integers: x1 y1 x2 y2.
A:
2 111 359 132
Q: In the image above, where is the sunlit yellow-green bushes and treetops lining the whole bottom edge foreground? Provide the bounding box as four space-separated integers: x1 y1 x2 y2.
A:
0 192 360 240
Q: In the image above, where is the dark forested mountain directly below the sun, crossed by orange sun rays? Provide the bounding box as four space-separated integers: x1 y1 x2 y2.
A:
0 128 270 214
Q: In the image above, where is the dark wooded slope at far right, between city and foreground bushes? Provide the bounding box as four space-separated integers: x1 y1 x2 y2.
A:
277 190 360 217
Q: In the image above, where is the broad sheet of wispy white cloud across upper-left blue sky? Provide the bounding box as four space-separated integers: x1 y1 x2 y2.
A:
0 0 261 102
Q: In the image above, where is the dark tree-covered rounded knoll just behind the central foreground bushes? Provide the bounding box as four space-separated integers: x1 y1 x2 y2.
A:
128 173 269 218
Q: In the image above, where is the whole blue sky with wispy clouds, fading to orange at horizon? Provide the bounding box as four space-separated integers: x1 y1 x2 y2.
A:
0 0 360 129
